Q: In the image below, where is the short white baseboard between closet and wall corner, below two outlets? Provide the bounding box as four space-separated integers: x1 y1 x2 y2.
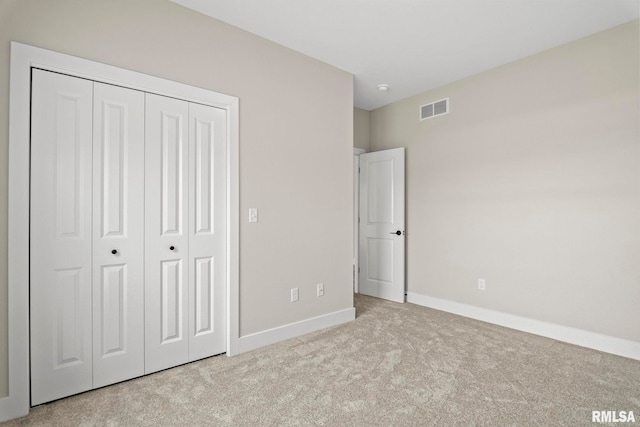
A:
238 307 356 354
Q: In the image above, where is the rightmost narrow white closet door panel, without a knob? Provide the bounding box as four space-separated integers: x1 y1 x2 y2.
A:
189 103 227 360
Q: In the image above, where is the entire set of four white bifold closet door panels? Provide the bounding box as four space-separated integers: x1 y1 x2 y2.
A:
29 70 227 405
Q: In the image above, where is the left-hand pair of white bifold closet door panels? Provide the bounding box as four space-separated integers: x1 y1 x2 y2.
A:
30 70 144 405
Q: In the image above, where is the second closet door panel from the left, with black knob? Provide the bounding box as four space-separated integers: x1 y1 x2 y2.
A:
93 83 144 388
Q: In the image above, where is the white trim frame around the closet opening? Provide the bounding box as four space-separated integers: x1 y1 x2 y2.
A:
5 42 240 421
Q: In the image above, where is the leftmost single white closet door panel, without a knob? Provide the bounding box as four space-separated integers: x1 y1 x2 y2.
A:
30 70 93 405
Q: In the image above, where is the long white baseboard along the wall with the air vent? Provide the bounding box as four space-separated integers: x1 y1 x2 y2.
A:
407 292 640 360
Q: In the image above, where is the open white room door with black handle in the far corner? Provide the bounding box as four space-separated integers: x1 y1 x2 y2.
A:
359 148 405 302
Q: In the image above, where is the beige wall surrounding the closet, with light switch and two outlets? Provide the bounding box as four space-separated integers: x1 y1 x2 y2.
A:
0 0 353 397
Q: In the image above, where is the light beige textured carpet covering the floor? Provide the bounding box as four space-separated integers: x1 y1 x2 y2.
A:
2 295 640 427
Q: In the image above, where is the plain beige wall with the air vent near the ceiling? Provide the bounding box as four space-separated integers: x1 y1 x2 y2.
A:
370 20 640 341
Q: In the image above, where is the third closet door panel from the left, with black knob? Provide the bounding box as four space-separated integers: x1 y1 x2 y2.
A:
145 94 189 373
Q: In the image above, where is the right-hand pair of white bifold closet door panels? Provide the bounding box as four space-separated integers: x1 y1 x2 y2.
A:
145 94 227 373
